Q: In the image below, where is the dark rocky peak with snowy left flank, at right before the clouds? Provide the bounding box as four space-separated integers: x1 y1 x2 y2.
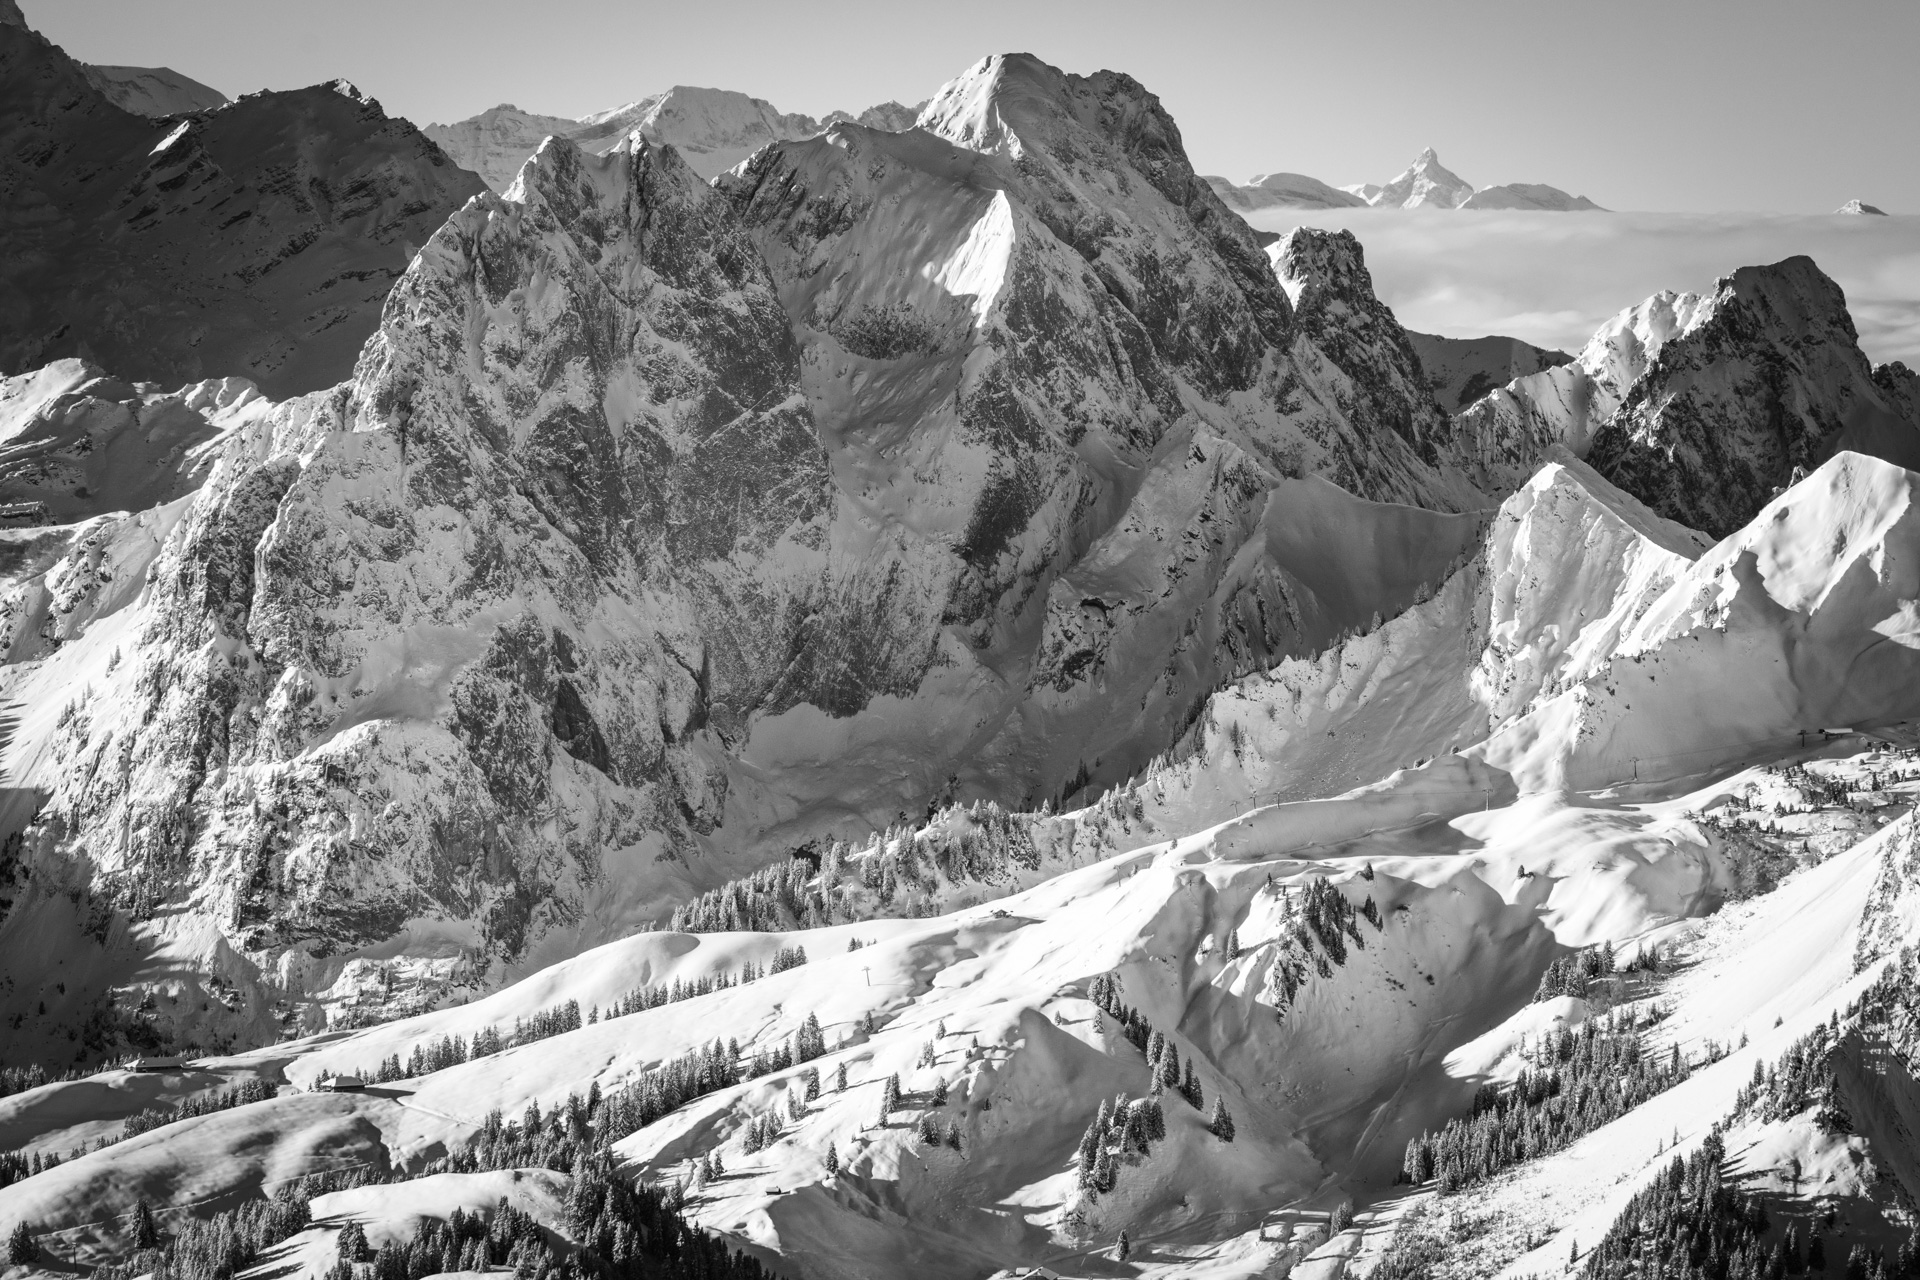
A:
1453 257 1920 521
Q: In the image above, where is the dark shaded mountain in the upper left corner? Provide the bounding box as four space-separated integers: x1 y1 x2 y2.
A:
0 23 484 395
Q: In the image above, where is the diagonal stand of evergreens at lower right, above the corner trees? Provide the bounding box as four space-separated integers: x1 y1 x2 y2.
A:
1402 1015 1688 1194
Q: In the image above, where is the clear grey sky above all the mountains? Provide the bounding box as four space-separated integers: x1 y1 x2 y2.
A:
21 0 1920 213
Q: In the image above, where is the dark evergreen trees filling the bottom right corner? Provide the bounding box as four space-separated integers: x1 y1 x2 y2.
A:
1586 1128 1920 1280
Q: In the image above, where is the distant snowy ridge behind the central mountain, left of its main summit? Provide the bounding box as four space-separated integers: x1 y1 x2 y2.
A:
426 84 918 192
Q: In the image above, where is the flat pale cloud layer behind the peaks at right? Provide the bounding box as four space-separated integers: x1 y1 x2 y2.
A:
1248 209 1920 368
